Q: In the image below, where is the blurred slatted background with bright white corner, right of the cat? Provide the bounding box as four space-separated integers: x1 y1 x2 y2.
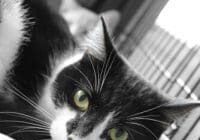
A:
49 0 200 140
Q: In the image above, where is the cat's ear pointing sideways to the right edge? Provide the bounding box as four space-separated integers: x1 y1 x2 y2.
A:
161 99 200 120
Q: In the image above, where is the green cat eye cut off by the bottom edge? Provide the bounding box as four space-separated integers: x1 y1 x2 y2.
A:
108 128 128 140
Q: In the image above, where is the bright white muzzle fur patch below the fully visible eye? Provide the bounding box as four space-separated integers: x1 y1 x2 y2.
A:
50 107 77 140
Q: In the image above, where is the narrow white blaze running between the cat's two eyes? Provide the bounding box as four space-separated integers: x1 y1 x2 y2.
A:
68 113 113 140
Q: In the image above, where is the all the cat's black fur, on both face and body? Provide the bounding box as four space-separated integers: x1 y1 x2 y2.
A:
0 0 195 140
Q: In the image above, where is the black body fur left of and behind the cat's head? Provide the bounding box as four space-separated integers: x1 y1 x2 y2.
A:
0 0 75 140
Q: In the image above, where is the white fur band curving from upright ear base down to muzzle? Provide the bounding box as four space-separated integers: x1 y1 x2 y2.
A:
39 52 87 140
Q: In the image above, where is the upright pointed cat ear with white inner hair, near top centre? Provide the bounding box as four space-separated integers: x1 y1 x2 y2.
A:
83 17 115 60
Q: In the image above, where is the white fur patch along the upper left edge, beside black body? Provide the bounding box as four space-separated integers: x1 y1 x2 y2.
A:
0 0 25 86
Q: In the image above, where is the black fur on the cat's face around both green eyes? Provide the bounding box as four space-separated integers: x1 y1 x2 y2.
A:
54 22 169 140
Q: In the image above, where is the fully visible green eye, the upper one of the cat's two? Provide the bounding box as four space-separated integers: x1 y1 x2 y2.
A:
74 90 89 111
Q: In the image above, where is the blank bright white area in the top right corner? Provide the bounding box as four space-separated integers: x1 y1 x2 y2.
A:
156 0 200 46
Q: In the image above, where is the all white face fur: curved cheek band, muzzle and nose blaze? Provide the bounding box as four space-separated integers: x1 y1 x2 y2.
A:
39 52 112 140
